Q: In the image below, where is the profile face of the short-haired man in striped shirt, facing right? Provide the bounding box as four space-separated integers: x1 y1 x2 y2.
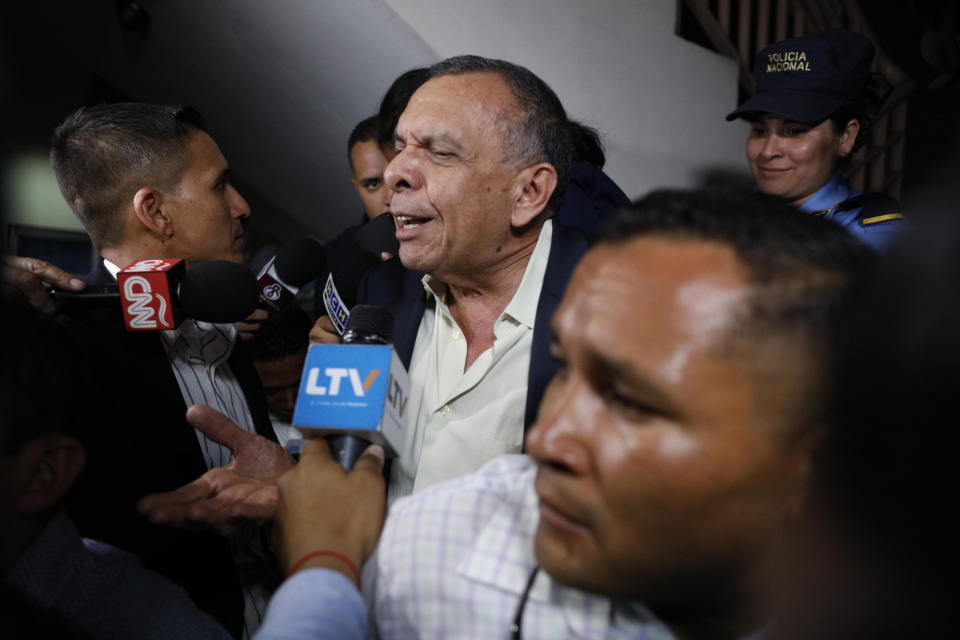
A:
167 132 250 264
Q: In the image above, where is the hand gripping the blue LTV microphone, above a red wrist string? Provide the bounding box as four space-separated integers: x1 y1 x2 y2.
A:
275 438 386 580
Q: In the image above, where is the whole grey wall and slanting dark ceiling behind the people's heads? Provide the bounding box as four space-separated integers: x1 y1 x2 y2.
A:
7 0 745 252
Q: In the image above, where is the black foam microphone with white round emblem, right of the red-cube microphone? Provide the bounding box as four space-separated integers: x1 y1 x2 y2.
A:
257 238 327 311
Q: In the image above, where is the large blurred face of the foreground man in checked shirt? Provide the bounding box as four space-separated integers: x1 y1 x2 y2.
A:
527 237 800 606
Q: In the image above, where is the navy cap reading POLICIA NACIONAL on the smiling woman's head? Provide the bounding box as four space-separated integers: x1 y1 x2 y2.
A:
727 29 874 122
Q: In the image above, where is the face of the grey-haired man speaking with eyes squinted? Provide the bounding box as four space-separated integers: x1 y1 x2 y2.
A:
384 73 517 280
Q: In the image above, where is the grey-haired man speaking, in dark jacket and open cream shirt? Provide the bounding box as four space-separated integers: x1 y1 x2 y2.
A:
326 56 589 497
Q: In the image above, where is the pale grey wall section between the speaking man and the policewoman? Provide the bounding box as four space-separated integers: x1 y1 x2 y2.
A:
387 0 746 197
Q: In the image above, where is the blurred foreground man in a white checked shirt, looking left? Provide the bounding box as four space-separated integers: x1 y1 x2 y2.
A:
370 191 867 640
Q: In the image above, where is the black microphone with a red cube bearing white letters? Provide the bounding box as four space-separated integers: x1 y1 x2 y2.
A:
50 258 257 331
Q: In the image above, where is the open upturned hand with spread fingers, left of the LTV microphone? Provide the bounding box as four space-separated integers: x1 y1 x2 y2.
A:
137 404 293 534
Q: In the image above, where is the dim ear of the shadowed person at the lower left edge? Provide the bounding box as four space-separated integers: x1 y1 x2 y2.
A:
15 434 87 514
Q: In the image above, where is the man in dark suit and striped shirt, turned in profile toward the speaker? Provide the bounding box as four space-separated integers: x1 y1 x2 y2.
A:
45 103 277 635
